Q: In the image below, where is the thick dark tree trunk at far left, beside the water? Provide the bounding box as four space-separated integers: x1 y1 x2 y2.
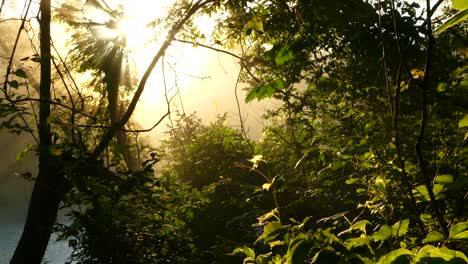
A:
10 0 63 264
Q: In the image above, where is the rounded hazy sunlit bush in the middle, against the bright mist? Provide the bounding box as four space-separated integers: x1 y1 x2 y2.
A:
159 113 253 189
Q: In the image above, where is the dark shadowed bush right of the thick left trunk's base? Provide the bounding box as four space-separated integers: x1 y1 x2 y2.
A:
57 156 207 263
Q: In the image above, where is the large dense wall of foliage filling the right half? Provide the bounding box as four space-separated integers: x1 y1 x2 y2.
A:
225 1 468 263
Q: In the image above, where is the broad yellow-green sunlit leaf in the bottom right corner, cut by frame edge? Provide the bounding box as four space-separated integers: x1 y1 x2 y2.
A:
412 245 468 264
